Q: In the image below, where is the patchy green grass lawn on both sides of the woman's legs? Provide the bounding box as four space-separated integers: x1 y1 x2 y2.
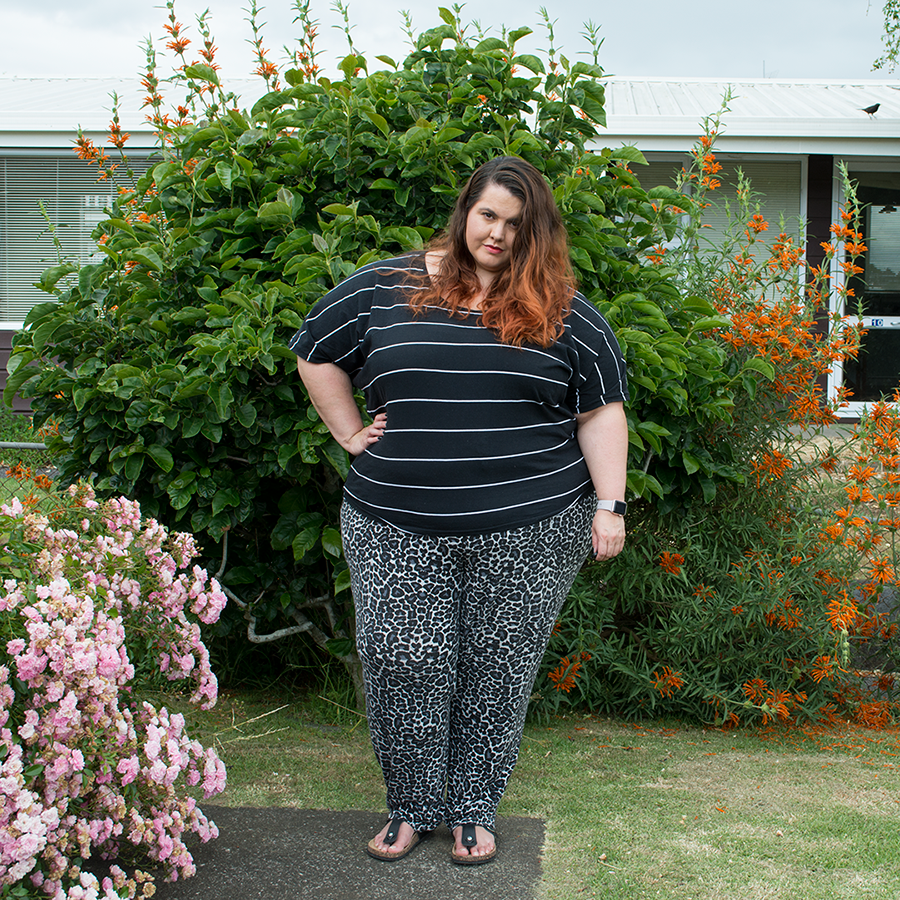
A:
162 692 900 900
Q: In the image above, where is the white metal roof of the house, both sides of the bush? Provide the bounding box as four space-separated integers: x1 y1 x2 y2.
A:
0 76 900 156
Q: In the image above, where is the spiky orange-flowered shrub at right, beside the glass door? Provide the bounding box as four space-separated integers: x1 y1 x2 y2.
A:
549 105 900 727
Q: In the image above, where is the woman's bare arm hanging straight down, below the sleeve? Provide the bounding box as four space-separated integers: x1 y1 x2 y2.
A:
575 403 628 560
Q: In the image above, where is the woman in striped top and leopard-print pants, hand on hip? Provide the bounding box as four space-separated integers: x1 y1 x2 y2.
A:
291 157 628 865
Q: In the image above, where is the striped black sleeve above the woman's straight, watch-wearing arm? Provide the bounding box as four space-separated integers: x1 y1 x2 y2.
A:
567 294 628 413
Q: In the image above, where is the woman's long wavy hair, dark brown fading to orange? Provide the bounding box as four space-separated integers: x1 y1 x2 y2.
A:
410 156 576 347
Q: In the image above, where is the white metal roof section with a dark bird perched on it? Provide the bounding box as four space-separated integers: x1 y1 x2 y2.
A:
600 78 900 156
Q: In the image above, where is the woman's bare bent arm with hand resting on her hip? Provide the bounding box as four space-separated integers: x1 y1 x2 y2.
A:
297 357 387 456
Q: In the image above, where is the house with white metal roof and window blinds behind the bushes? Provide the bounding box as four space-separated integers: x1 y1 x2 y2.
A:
0 77 900 413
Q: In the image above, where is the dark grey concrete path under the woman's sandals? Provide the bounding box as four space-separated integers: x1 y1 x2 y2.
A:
155 803 544 900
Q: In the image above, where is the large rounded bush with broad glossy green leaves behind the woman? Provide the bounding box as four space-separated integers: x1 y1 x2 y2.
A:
7 3 744 712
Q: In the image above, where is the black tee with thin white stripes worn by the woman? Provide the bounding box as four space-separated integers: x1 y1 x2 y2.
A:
290 254 628 534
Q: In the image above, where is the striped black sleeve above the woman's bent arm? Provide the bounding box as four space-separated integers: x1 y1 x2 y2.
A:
288 267 377 378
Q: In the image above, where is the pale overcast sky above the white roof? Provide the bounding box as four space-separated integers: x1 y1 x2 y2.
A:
0 0 900 82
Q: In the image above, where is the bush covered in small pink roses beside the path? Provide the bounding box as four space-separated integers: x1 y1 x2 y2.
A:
0 486 226 900
